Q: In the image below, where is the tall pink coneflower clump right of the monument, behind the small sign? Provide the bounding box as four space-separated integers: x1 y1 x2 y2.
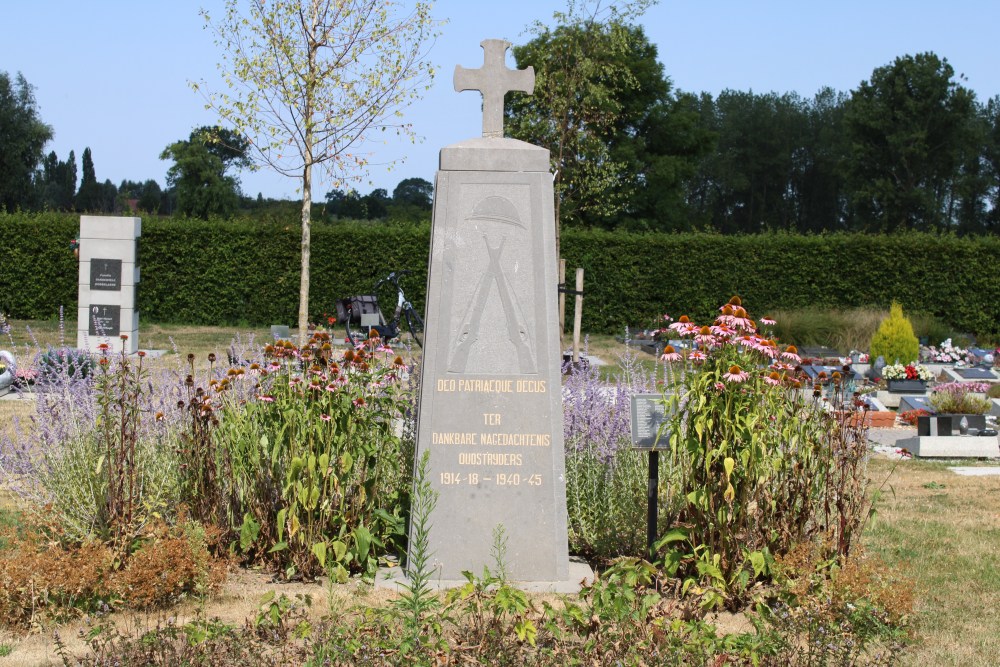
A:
659 297 867 607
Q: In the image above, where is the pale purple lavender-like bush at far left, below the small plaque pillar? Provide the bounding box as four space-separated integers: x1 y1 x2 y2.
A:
0 336 177 542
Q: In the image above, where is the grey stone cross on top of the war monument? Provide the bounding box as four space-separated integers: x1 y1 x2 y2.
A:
455 39 535 138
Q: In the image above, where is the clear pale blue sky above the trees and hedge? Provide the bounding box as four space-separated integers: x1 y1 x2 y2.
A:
0 0 1000 200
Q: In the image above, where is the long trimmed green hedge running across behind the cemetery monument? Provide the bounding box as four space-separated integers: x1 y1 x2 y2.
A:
0 214 1000 339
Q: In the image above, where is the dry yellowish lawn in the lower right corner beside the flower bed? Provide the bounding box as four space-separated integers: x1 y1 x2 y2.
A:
866 460 1000 667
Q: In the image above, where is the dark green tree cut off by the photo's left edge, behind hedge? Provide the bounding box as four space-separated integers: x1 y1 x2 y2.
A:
0 72 52 211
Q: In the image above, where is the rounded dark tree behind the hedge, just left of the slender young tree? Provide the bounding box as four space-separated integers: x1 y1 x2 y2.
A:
160 127 250 219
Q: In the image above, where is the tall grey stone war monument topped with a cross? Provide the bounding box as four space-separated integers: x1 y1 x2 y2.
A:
410 39 570 590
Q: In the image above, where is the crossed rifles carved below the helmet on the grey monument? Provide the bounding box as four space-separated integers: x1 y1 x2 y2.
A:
448 234 535 373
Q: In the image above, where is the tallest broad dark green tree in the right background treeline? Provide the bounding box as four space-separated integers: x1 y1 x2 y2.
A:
845 53 975 231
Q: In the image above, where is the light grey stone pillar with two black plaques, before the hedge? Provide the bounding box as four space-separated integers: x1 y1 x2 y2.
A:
76 215 142 354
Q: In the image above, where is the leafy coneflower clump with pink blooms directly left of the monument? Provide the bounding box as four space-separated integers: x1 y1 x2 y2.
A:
215 332 407 582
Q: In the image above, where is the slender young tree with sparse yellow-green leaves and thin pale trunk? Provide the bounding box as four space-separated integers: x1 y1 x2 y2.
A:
195 0 433 343
